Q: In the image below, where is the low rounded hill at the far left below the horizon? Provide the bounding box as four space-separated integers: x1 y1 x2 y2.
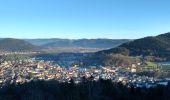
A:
0 38 39 51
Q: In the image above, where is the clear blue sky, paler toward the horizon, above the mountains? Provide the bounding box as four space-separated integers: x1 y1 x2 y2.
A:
0 0 170 39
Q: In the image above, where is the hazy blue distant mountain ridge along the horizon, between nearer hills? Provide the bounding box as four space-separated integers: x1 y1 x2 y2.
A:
26 39 130 48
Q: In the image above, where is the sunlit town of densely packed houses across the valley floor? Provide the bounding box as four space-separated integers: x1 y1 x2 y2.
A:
0 59 168 87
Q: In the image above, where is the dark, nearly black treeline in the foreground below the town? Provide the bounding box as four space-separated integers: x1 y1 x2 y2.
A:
0 79 170 100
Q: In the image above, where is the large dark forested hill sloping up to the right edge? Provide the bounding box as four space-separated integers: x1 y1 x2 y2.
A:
98 32 170 59
